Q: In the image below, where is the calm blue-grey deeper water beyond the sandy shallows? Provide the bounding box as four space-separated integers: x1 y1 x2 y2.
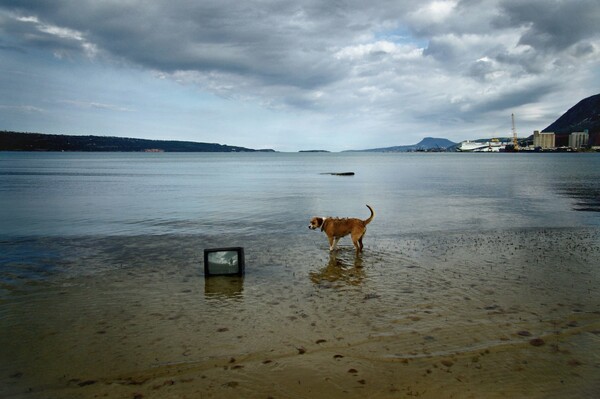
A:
0 153 600 238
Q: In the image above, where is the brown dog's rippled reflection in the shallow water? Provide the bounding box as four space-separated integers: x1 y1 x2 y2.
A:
309 251 365 285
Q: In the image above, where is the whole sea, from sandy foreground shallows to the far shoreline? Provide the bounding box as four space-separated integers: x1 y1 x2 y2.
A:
0 152 600 398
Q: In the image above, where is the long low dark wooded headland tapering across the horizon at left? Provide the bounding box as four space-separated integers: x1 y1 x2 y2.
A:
0 131 274 152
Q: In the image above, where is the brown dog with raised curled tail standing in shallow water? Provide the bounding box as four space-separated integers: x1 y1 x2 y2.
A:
308 205 375 255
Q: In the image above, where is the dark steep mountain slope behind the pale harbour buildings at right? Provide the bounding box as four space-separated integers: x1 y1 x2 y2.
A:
543 94 600 146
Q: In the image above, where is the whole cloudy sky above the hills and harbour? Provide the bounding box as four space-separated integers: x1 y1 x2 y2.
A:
0 0 600 151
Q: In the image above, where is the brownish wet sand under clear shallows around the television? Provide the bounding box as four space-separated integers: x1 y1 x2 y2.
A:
0 228 600 398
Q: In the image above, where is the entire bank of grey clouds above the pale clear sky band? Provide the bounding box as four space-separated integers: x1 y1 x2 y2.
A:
0 0 600 148
